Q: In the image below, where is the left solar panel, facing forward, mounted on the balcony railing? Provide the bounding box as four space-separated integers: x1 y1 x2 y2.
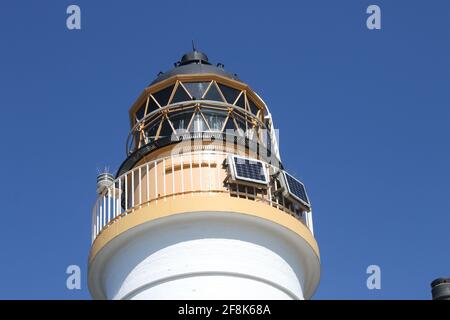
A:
229 156 268 184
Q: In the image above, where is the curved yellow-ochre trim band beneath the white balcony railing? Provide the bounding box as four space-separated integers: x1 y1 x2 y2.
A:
89 193 320 262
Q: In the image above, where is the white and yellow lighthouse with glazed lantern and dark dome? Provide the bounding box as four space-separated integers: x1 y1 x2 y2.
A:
88 49 320 300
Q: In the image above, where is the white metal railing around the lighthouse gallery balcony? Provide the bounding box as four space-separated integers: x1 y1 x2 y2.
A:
92 151 312 241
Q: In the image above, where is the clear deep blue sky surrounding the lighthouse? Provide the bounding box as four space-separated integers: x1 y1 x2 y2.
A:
0 0 450 299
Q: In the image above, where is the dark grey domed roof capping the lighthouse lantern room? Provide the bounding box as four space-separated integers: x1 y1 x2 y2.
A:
150 49 239 85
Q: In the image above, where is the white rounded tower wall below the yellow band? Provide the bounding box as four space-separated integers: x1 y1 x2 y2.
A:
89 212 320 299
